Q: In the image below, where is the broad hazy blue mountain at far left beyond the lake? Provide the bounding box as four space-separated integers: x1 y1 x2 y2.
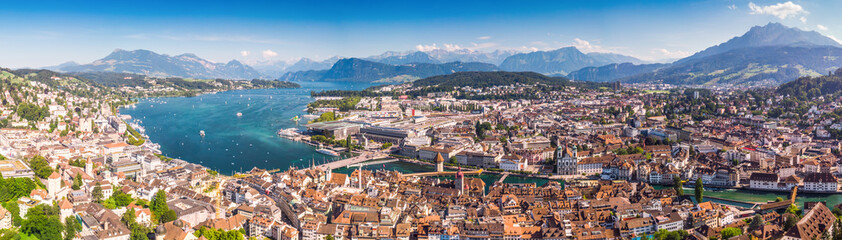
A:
61 49 261 79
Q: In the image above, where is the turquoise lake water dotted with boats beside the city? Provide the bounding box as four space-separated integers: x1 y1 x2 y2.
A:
120 83 371 174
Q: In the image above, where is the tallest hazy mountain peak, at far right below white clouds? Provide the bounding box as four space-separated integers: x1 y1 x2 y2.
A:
676 23 842 63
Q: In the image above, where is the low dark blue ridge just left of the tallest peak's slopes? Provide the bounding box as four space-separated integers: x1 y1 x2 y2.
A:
567 63 669 82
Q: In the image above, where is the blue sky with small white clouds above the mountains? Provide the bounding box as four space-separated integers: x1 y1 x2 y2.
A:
0 0 842 68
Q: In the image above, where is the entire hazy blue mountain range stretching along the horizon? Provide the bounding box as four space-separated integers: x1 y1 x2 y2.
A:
42 23 842 85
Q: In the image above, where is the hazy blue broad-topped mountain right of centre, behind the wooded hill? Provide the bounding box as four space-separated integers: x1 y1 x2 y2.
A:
500 47 608 75
